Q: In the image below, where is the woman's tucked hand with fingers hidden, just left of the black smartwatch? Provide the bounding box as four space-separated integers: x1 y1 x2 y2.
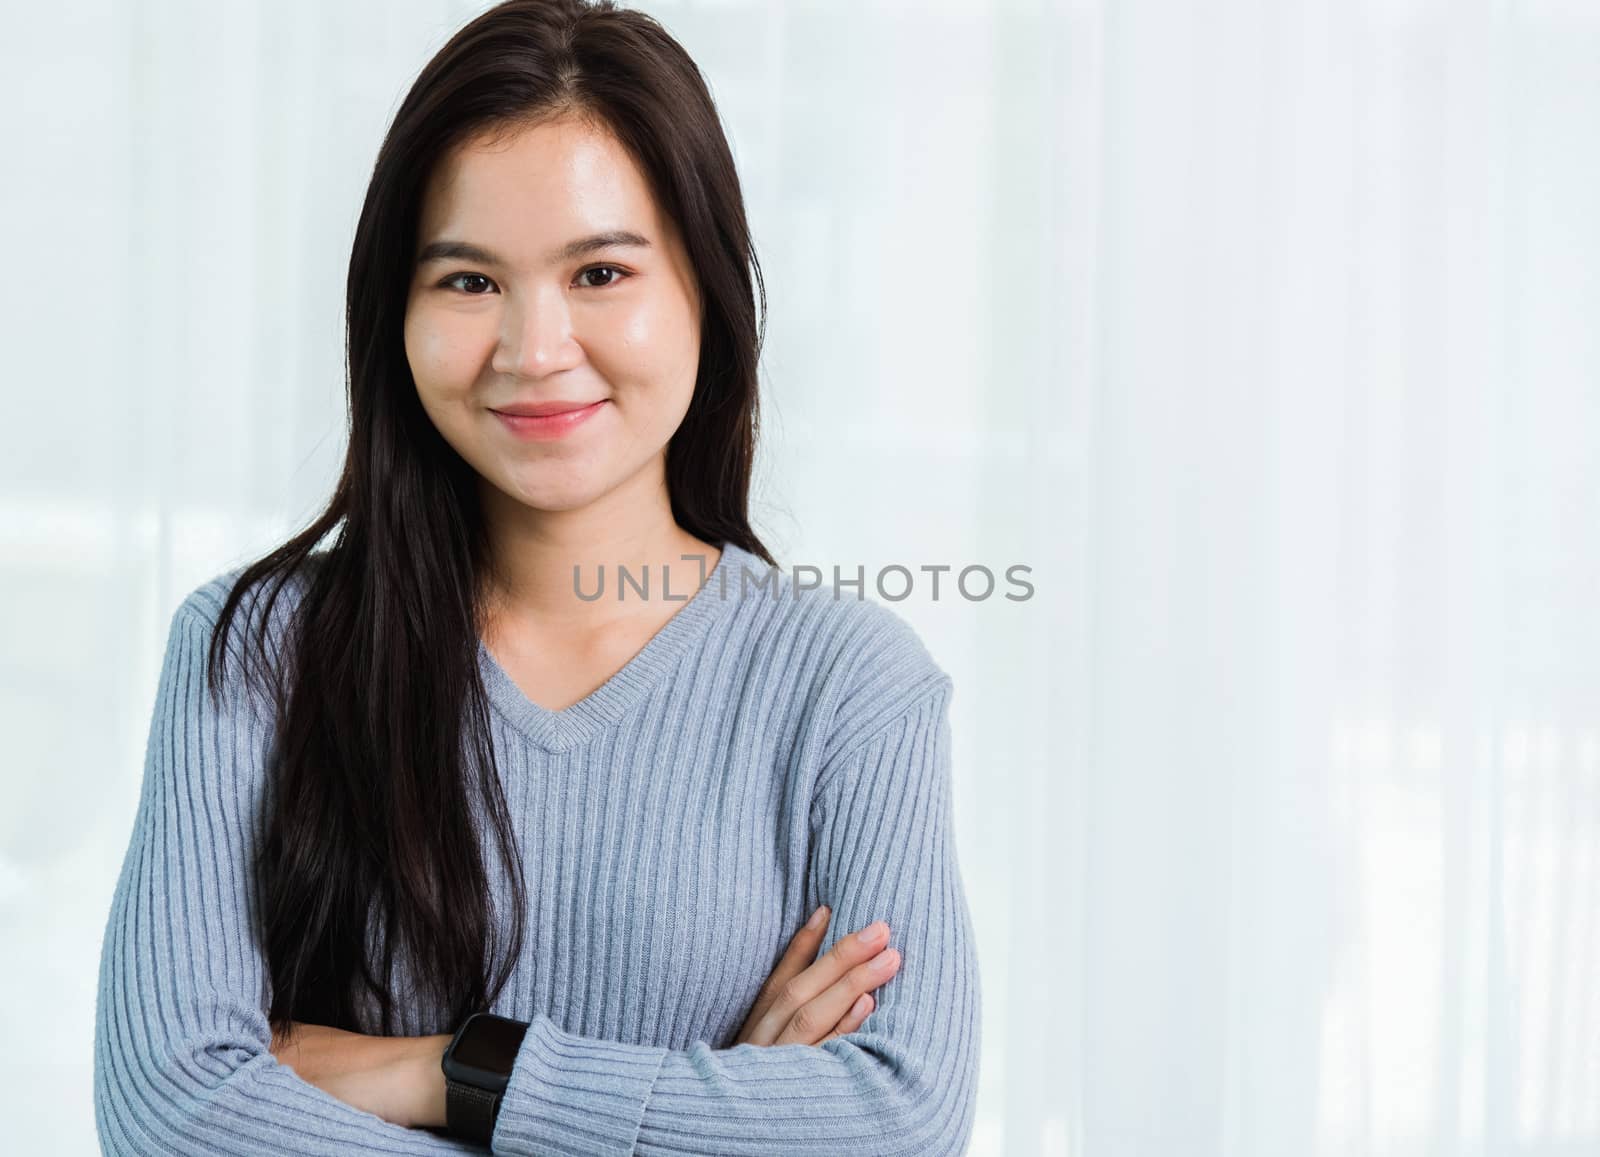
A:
272 1021 450 1128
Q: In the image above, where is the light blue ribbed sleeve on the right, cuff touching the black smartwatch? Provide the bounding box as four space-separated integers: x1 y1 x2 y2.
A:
491 677 979 1157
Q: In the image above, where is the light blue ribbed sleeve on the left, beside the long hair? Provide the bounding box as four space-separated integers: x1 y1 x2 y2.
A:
94 594 483 1157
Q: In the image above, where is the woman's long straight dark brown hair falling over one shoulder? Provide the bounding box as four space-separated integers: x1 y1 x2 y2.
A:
208 0 776 1035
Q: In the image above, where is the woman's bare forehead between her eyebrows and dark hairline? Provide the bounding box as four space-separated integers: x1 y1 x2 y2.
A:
418 118 667 254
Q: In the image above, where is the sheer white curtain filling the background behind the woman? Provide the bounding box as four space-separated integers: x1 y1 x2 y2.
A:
0 0 1600 1157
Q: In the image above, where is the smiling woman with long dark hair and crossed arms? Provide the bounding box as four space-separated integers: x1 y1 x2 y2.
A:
94 0 979 1157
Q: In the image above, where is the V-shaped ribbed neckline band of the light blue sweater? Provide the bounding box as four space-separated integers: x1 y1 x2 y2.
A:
478 542 748 752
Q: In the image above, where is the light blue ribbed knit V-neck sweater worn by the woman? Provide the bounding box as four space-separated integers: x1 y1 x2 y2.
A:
94 542 981 1157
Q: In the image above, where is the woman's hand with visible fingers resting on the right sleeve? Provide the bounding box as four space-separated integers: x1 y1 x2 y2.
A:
733 907 899 1045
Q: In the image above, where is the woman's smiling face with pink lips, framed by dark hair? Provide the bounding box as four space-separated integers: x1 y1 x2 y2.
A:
405 118 701 510
